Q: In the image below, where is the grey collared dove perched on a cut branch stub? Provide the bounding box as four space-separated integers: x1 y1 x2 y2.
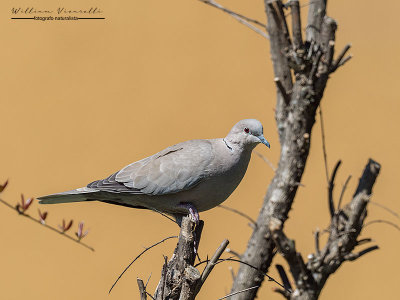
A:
38 119 270 221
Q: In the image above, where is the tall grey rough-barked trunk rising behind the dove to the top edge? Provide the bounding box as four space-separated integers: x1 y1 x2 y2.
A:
231 0 348 300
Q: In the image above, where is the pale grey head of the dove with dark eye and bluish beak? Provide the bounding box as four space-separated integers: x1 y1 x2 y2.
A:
226 119 270 149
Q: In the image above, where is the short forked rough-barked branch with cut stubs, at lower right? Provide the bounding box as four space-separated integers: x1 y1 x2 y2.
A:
270 159 381 300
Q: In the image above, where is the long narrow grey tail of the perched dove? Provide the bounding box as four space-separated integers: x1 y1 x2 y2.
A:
38 188 98 204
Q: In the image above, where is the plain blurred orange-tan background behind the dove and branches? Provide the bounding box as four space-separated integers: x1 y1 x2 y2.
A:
0 0 400 300
